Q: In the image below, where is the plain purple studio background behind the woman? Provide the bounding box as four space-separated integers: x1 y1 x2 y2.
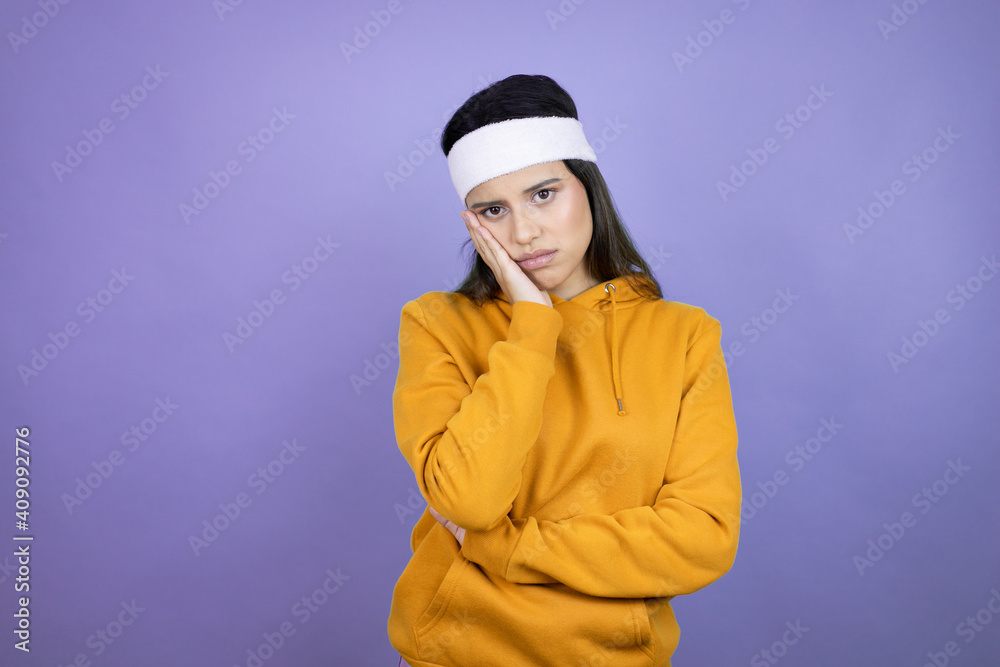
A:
0 0 1000 666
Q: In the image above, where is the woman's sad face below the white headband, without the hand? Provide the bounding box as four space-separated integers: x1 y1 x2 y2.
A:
465 160 597 300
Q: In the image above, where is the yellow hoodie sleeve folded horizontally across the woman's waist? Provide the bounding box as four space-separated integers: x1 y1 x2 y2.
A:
462 318 741 597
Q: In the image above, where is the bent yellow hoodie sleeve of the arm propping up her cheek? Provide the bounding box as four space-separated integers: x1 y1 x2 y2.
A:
392 301 562 530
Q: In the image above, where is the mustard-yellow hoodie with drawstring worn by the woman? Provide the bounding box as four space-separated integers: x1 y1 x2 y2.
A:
388 278 741 667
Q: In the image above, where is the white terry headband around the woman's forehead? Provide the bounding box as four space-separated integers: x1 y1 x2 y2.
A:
448 116 597 204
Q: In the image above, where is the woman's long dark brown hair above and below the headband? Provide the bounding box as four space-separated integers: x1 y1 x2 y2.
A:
441 74 663 306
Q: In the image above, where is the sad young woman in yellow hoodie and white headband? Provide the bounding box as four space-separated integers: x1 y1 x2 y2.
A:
388 75 741 667
